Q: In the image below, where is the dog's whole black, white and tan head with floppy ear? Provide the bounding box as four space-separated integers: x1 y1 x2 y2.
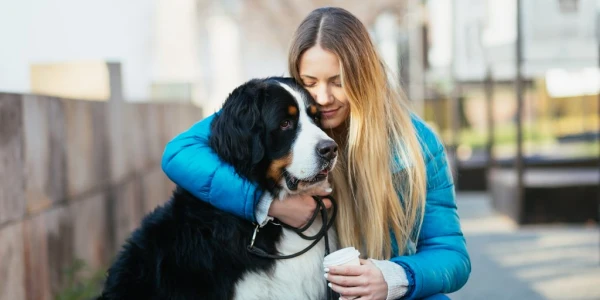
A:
210 77 337 197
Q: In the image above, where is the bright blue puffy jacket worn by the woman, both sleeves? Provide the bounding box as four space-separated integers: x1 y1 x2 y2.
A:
162 115 471 299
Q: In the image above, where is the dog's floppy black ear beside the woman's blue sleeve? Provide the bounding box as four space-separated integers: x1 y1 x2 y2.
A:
210 80 266 178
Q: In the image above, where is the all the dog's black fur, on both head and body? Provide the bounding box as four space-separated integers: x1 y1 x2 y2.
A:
99 78 330 300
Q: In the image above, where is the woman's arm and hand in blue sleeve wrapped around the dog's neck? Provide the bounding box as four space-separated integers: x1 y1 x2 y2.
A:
162 115 331 228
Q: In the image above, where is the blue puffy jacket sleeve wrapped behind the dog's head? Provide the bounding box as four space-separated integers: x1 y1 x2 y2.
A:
162 115 262 221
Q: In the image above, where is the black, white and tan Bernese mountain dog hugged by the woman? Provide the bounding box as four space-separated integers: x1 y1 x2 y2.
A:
100 77 337 300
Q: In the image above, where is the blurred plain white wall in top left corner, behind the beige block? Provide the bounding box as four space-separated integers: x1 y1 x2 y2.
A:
0 0 154 100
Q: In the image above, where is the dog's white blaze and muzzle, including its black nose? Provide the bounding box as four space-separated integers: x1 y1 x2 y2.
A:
279 83 337 196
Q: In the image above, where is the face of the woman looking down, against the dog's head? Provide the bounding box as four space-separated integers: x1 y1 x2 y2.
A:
299 45 350 129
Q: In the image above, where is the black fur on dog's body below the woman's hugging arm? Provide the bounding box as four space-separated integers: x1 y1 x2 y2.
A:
100 189 281 300
